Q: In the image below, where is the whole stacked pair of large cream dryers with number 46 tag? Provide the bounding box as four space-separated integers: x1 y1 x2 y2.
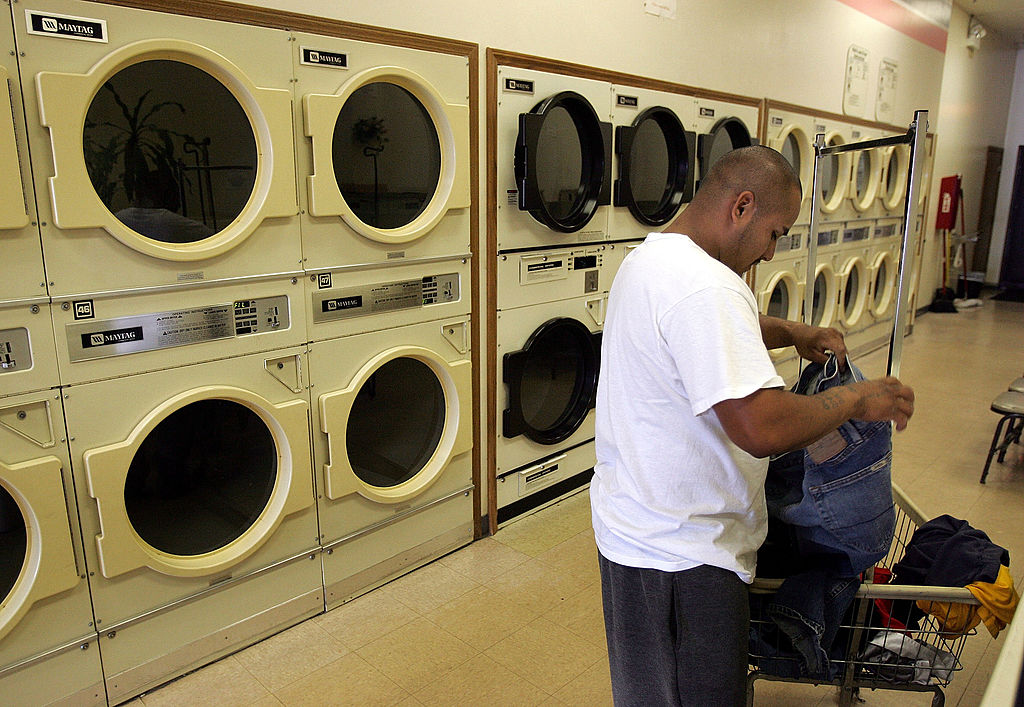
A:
15 0 324 702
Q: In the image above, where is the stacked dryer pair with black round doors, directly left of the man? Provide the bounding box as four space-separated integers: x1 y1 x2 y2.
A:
488 66 612 528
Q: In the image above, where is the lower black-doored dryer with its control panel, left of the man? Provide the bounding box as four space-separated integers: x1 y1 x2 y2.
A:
493 244 606 525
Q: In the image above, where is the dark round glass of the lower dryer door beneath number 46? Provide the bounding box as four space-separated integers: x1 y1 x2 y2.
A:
124 399 279 556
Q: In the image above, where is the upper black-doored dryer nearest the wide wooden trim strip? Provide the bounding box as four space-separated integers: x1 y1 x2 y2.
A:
494 66 612 252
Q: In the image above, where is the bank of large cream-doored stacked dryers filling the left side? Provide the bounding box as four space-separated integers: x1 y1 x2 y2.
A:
0 0 475 704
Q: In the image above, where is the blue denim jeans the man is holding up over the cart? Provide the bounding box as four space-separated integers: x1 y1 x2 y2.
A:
765 354 896 577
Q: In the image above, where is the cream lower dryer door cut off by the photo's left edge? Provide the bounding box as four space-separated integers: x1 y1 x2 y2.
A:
0 454 81 639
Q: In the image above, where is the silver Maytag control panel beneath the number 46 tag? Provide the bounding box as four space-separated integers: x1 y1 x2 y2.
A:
66 295 290 362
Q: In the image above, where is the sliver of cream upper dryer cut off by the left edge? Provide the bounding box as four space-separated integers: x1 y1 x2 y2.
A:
0 12 46 301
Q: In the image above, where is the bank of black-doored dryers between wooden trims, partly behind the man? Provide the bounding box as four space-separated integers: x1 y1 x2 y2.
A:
487 63 760 524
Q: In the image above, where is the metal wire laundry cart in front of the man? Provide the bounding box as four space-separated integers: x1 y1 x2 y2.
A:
746 485 979 707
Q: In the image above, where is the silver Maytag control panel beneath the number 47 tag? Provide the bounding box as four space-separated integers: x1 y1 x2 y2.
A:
312 273 461 324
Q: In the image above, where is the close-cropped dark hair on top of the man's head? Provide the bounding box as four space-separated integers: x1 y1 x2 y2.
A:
693 145 803 216
